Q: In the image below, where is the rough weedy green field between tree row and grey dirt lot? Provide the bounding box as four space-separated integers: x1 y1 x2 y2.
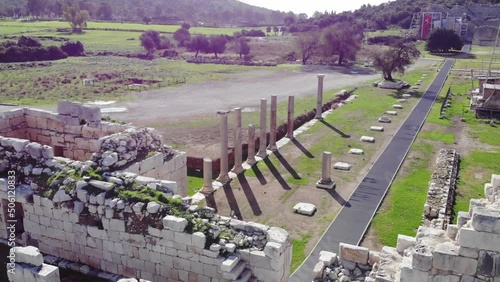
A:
0 56 290 106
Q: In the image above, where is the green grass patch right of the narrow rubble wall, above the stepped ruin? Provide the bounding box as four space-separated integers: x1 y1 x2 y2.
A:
453 151 500 219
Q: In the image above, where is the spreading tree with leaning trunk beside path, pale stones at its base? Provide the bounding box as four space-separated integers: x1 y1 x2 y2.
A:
373 41 420 81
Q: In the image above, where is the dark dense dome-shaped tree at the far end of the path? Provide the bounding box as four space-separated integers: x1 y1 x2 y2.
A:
425 28 464 52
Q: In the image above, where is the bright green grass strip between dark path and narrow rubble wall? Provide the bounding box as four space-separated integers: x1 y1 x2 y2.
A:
372 142 434 247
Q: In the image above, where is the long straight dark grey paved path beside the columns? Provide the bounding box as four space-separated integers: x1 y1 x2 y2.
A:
290 60 454 282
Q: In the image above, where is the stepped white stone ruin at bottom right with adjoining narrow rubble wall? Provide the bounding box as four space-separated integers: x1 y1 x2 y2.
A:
313 150 500 282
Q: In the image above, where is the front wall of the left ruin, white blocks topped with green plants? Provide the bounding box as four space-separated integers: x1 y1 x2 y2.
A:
0 137 291 282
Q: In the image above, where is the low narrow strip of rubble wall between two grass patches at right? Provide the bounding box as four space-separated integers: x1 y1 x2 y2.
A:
424 149 459 229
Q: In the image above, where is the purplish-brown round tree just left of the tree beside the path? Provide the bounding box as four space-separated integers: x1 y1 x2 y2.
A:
321 22 363 65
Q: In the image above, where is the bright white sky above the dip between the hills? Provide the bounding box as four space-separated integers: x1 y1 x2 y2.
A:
238 0 389 17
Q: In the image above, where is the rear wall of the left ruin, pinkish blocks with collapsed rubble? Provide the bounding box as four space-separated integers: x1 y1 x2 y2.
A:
0 101 187 195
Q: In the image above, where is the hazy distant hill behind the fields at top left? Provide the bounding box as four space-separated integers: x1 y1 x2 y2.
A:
0 0 290 25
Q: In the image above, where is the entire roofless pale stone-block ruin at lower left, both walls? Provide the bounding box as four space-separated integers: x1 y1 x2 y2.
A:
0 102 291 282
